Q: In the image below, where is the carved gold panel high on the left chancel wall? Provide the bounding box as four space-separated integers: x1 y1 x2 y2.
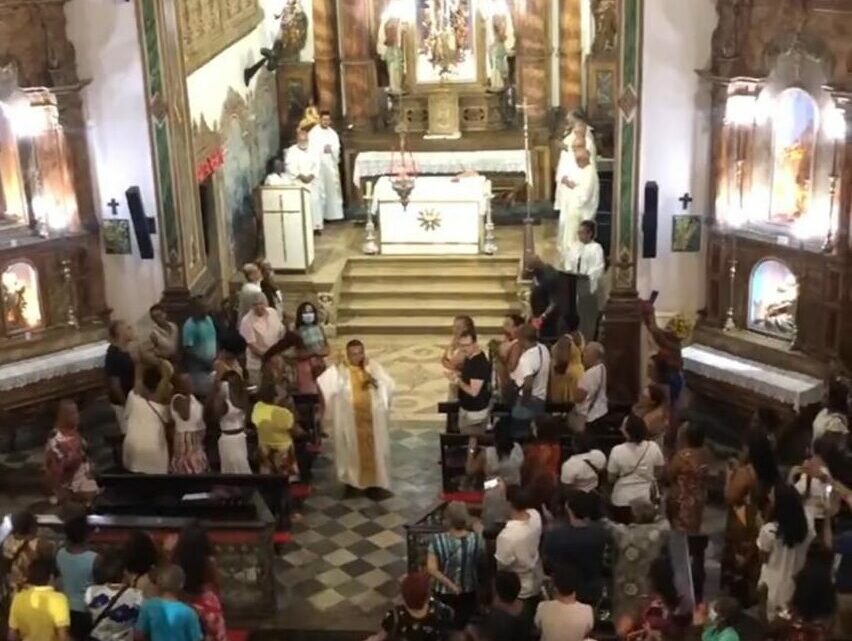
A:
177 0 262 75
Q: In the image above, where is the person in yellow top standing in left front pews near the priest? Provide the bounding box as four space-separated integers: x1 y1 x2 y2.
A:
251 379 302 478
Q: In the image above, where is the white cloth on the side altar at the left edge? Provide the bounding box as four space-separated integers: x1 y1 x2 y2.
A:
0 341 109 392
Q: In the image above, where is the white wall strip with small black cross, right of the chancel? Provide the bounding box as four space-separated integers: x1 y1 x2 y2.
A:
638 0 717 317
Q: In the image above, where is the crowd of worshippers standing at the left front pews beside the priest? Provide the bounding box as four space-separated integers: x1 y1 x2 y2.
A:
45 263 328 504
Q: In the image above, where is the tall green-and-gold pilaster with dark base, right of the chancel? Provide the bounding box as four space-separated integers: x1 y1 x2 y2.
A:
602 0 644 405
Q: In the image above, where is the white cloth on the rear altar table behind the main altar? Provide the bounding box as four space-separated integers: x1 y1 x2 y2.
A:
352 149 527 186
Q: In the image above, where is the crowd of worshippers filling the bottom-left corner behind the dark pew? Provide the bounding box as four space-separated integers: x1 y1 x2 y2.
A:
0 508 236 641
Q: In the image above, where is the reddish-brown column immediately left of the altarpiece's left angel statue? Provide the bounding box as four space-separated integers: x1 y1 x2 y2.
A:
337 0 376 128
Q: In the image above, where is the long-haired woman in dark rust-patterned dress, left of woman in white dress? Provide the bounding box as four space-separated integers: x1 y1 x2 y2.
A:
721 430 780 608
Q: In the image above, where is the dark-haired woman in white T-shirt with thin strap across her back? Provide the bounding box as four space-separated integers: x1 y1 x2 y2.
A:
607 414 665 523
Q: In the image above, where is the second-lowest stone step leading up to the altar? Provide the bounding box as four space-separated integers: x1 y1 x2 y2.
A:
338 296 520 318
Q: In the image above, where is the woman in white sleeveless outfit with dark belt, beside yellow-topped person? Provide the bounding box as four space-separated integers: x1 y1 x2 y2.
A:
216 372 252 474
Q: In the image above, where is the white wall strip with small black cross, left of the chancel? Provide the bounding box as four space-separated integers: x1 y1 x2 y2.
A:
65 0 163 323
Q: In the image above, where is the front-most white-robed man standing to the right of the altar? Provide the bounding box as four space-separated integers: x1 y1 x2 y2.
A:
557 146 600 269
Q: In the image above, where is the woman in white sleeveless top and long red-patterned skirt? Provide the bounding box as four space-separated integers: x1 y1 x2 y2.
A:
169 374 210 474
